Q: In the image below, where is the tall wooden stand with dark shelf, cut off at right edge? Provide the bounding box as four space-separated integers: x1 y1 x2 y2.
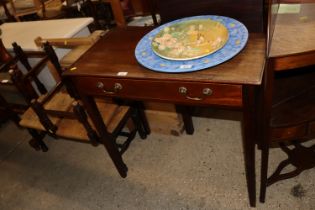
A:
260 1 315 202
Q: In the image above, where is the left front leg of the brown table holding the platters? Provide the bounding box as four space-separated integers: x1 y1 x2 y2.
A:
80 94 128 178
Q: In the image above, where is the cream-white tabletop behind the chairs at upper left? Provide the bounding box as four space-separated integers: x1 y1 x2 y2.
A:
0 18 93 51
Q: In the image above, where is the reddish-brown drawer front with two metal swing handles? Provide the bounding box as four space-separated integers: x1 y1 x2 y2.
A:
74 77 242 107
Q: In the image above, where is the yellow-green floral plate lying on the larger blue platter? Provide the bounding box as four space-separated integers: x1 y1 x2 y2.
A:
152 19 229 60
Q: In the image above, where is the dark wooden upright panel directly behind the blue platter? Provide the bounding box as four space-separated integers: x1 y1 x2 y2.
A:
156 0 265 32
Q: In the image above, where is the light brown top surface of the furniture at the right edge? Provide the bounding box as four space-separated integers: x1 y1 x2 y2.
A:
269 3 315 57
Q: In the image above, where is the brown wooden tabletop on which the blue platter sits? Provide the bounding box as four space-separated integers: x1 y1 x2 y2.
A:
64 27 266 85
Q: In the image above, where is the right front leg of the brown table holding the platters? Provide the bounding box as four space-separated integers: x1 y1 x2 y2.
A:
242 86 256 207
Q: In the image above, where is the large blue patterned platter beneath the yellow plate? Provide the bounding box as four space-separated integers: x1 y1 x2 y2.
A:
135 15 248 73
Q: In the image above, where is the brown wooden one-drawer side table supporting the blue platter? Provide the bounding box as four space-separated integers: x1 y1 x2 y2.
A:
63 23 266 206
